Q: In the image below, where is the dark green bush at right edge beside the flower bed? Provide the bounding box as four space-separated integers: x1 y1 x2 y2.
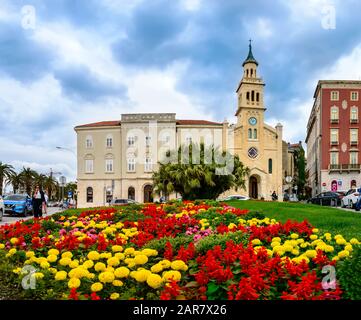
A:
336 246 361 300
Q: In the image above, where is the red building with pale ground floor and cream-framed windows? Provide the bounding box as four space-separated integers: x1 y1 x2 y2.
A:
306 80 361 195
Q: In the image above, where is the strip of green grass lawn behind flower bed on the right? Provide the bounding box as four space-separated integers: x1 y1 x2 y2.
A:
228 201 361 239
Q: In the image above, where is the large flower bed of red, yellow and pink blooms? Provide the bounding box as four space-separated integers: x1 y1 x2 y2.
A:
0 202 359 300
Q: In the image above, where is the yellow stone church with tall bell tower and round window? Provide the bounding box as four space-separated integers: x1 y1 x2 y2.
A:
228 41 287 200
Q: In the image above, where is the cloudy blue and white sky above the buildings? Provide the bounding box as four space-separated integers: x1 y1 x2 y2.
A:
0 0 361 179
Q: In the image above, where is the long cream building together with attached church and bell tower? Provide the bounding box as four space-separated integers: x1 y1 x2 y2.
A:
75 45 287 207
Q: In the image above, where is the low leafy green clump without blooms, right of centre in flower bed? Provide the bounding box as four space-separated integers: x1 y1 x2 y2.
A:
196 231 248 254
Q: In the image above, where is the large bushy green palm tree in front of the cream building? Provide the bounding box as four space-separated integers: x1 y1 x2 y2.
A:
153 144 249 200
